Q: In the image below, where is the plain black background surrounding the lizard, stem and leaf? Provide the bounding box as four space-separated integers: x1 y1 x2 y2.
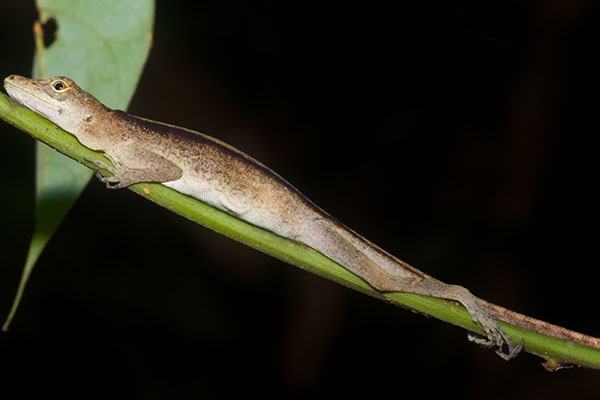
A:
0 0 600 399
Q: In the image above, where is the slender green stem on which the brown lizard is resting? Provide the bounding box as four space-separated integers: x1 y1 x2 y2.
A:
0 94 600 369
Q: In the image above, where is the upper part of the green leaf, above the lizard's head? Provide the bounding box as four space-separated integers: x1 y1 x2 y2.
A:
37 0 154 110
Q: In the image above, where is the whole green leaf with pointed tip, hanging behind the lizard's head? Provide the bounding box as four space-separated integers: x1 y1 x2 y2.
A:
3 0 154 330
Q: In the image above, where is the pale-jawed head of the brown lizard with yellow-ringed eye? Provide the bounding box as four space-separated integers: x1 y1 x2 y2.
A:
4 75 107 144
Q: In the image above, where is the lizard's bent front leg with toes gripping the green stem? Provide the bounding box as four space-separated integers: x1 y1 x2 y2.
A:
85 150 183 189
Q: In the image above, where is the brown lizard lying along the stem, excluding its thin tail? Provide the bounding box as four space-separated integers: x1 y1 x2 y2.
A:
4 75 522 360
